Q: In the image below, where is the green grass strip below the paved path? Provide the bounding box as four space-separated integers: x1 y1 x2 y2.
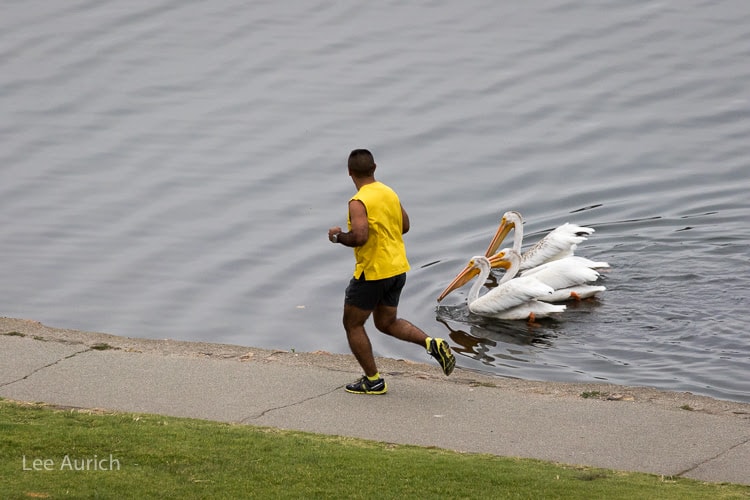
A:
0 400 750 500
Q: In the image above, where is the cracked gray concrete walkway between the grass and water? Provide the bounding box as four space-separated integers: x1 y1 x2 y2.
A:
0 318 750 485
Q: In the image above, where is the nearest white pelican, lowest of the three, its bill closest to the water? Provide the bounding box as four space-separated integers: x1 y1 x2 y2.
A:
438 250 565 322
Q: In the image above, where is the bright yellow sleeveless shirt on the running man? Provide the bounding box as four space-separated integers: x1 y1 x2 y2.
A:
347 182 410 281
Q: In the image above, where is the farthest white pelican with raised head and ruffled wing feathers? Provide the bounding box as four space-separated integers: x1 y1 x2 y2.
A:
485 211 609 271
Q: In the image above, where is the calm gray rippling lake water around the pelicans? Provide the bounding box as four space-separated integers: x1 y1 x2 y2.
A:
0 0 750 402
